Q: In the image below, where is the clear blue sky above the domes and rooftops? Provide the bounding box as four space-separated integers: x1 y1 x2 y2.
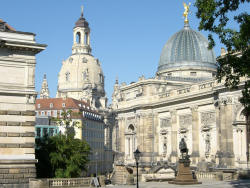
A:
0 0 249 102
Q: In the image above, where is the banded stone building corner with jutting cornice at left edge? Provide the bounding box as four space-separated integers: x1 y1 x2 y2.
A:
0 20 46 186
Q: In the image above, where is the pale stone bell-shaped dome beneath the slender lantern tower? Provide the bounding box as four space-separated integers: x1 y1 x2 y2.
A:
58 54 105 99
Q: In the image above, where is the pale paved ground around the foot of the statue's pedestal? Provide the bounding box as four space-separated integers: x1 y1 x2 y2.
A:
108 180 250 188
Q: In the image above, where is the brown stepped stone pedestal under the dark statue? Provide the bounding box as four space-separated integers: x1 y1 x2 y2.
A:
168 159 201 185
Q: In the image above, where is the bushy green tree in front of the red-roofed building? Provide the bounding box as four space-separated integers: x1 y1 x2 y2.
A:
36 111 90 178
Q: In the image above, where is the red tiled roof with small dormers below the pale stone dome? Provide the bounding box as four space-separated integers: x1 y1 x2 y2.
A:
36 98 96 113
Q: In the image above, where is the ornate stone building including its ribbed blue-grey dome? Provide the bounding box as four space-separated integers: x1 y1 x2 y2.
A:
112 20 249 183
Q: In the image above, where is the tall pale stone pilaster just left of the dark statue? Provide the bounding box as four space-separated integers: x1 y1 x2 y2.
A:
170 110 178 163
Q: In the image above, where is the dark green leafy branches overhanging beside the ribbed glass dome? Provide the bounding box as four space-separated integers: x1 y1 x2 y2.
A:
195 0 250 117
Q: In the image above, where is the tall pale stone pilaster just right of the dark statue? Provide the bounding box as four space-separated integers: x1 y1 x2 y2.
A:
191 106 200 164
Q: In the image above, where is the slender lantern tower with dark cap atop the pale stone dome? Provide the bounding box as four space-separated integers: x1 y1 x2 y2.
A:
72 6 91 54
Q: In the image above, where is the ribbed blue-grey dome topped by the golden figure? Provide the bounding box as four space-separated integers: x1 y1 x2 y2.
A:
157 24 217 74
